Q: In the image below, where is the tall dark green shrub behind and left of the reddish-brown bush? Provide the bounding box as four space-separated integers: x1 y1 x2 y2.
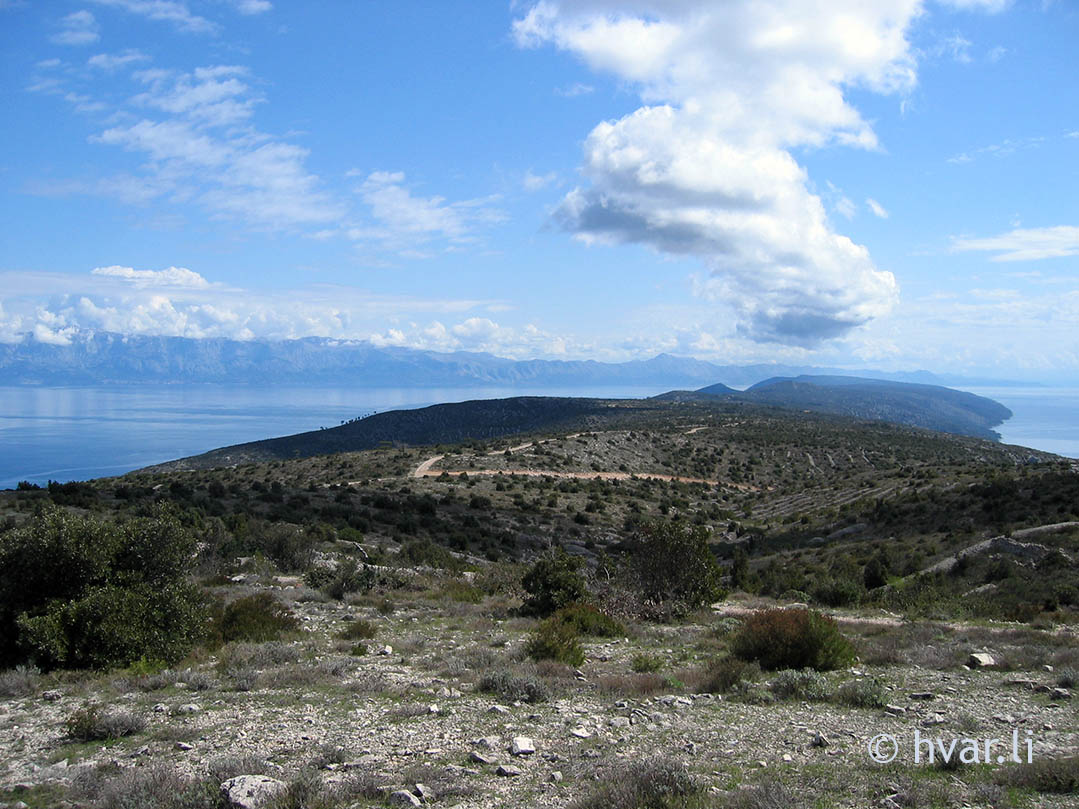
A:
629 521 726 614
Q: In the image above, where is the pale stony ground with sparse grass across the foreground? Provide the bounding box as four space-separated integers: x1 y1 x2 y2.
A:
0 580 1079 808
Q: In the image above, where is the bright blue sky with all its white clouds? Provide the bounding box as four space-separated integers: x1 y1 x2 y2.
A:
0 0 1079 382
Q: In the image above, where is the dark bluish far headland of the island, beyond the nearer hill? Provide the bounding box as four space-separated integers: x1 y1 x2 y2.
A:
655 375 1012 440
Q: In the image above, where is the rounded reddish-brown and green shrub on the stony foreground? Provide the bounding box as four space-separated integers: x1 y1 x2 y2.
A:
732 608 855 671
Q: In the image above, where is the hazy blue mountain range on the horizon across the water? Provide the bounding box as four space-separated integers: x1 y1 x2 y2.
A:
0 332 1028 388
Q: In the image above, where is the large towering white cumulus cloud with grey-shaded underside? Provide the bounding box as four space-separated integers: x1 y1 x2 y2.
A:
514 0 920 345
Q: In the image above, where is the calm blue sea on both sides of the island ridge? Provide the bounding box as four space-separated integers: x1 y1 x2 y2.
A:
0 385 1079 489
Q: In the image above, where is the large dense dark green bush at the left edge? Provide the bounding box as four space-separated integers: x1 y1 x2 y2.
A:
0 506 207 669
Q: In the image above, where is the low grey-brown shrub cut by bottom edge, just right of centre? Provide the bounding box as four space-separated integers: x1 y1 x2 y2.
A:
571 758 704 809
